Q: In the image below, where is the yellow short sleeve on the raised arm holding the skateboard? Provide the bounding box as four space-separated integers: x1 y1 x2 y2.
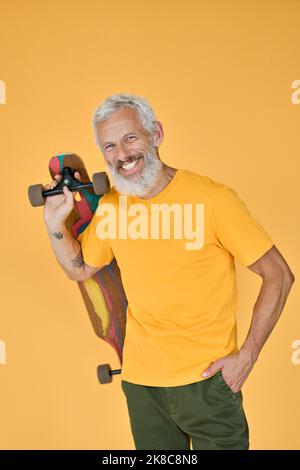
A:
78 199 114 268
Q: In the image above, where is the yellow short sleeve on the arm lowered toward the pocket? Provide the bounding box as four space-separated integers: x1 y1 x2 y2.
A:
212 186 274 266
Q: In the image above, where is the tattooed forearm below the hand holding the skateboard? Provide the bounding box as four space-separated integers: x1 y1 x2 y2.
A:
47 225 85 280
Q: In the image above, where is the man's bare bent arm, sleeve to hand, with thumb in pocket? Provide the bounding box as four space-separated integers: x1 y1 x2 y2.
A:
202 245 295 392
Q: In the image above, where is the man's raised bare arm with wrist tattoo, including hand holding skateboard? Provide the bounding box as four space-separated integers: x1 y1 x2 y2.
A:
44 172 103 281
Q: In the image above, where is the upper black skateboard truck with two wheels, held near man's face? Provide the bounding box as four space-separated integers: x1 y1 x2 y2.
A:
28 167 109 207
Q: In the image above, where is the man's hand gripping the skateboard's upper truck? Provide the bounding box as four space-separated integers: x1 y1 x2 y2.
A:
44 171 81 231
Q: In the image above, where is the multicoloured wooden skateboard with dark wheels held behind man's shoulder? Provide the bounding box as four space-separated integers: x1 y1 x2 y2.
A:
28 153 127 384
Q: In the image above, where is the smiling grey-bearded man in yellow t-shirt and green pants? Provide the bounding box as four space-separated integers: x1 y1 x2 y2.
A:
44 94 295 449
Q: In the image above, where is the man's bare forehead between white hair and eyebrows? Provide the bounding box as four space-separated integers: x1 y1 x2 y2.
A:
96 107 146 143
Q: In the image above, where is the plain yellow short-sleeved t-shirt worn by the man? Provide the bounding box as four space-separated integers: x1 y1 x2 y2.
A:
80 169 273 387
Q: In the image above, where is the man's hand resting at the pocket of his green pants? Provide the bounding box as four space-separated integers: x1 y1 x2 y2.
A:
202 351 254 393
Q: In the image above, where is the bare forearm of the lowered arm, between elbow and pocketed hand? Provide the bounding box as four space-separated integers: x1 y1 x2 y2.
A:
240 275 293 364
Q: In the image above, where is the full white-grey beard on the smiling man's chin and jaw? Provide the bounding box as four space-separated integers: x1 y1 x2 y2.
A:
107 147 163 197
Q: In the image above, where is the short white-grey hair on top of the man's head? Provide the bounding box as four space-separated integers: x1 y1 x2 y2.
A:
92 93 156 151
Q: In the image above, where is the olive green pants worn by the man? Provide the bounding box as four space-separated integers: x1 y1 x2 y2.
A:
121 371 249 450
